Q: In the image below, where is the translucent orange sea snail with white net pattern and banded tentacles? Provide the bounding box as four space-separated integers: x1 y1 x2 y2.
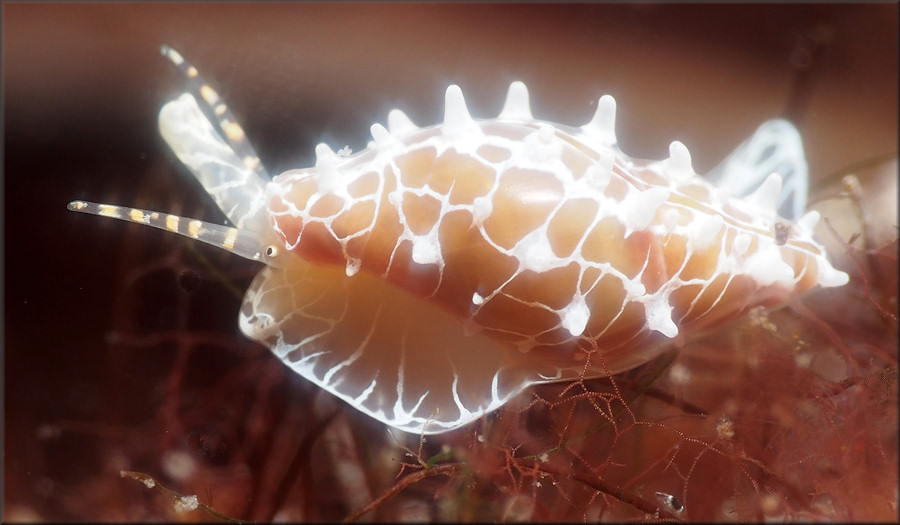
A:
69 46 848 434
